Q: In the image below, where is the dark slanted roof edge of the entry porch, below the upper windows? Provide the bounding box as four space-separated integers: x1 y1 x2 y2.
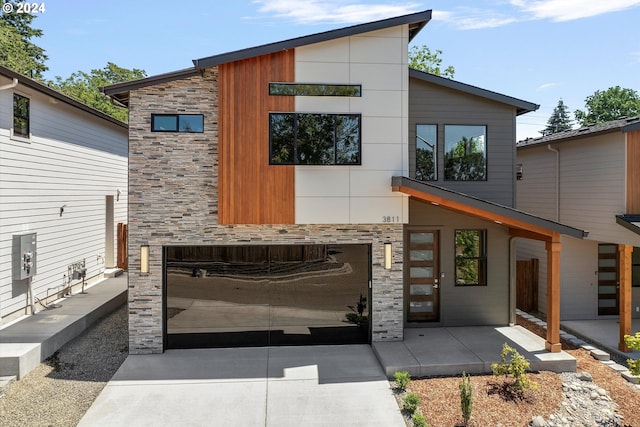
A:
391 176 589 239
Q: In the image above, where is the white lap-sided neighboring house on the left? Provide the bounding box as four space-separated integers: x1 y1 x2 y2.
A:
0 66 128 323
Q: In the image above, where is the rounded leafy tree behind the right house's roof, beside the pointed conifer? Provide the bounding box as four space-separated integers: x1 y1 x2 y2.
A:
574 86 640 126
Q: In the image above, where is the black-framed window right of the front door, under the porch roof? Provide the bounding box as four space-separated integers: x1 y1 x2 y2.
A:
455 230 487 286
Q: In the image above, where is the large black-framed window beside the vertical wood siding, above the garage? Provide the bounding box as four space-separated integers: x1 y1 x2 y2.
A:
269 113 361 165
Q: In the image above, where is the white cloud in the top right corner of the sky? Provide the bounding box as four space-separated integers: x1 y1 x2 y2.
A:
511 0 640 21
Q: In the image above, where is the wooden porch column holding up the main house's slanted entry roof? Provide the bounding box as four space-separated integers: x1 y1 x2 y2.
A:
545 233 562 353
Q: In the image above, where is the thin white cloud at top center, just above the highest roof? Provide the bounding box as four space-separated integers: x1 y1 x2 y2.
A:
254 0 422 24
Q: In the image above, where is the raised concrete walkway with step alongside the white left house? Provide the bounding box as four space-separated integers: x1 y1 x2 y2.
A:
0 274 127 381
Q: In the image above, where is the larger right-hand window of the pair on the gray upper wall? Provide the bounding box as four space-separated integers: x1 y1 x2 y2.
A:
444 125 487 181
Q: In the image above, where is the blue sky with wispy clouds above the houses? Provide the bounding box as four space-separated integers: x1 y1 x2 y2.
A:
33 0 640 139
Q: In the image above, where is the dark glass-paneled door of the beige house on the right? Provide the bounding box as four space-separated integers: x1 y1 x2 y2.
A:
598 244 620 316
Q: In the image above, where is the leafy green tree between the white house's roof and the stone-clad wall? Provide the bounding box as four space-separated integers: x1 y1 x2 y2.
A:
48 62 147 122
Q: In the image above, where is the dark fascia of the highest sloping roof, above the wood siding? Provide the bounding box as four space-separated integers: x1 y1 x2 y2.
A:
193 10 431 69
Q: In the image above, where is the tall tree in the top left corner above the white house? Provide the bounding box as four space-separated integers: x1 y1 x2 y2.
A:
0 0 49 80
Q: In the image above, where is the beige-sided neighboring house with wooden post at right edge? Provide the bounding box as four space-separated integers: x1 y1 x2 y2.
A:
517 117 640 349
